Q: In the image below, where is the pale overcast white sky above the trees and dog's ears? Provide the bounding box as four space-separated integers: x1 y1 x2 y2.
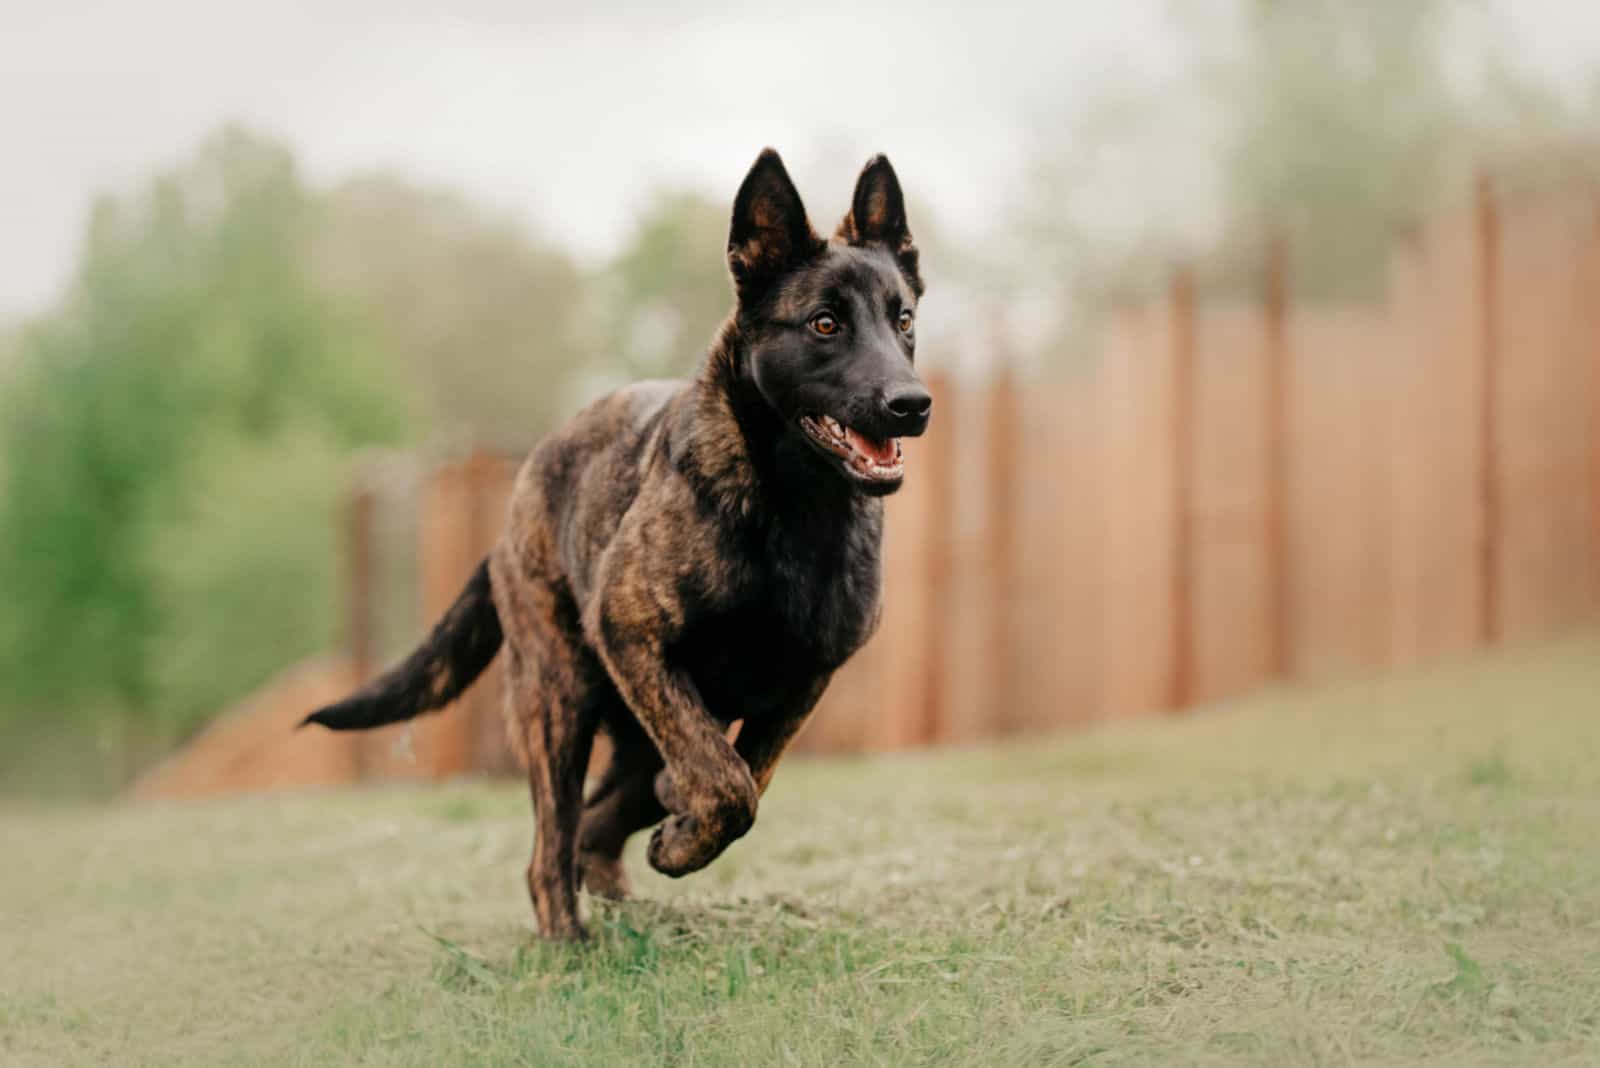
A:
0 0 1600 321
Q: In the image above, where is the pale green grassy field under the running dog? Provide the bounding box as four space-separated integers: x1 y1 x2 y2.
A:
0 638 1600 1065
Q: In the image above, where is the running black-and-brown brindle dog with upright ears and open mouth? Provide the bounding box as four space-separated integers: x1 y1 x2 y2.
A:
304 149 933 940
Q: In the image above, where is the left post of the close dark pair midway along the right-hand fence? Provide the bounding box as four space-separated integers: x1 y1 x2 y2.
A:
1168 264 1195 711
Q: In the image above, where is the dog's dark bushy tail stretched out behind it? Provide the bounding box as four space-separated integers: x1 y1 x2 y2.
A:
301 560 504 731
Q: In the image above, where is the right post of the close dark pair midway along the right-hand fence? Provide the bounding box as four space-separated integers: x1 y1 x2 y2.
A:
1264 232 1294 678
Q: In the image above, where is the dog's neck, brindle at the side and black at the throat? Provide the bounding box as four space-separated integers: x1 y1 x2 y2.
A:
672 318 880 526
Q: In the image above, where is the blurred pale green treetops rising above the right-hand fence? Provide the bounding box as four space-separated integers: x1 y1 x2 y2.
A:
1014 0 1594 349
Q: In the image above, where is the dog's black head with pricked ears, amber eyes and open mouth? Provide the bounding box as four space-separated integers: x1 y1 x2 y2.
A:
728 149 933 496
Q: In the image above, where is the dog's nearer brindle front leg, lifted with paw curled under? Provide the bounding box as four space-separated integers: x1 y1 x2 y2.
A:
595 593 758 876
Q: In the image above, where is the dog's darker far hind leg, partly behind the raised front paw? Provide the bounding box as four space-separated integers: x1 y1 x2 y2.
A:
578 722 667 900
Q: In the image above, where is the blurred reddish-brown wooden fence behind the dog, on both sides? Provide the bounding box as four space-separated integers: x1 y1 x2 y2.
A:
131 171 1600 793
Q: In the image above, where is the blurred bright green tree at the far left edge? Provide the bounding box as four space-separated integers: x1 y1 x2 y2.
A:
0 131 408 757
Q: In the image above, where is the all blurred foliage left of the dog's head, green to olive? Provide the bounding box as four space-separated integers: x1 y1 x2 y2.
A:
0 130 742 780
